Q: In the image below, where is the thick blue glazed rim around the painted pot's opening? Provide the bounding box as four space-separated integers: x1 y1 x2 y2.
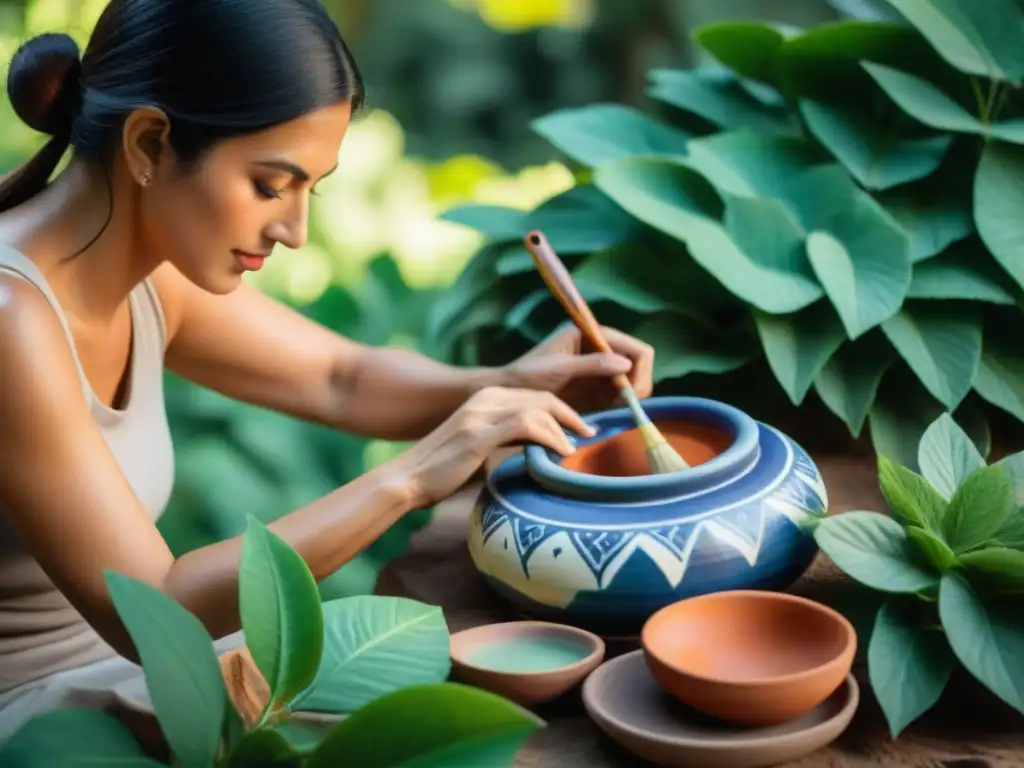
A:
523 396 761 501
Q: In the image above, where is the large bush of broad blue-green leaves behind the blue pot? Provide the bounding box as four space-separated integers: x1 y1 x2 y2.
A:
431 0 1024 468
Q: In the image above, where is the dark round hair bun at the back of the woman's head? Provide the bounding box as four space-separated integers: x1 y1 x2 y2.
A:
7 34 82 136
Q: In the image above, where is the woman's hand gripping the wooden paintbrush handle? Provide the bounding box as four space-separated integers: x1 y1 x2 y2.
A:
505 325 654 412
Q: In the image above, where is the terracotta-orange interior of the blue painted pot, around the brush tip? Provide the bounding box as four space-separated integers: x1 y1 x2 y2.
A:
561 420 733 477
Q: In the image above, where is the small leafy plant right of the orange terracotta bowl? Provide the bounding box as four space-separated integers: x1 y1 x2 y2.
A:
814 414 1024 738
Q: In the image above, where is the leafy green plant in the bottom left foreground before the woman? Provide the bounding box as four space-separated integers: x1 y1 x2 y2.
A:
0 515 543 768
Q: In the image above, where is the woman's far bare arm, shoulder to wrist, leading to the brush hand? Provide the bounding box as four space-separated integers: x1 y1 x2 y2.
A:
155 265 508 440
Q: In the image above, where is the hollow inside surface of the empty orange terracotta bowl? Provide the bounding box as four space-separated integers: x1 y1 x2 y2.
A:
644 597 850 682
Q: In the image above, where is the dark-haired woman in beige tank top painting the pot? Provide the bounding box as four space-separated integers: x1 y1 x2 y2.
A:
0 0 652 738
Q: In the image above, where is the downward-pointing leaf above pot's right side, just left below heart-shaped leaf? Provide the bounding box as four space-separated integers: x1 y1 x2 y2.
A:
754 302 844 406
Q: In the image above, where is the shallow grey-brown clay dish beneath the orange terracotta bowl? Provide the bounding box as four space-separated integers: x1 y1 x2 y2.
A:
583 650 860 768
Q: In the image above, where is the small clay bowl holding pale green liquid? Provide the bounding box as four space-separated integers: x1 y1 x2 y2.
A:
452 622 604 706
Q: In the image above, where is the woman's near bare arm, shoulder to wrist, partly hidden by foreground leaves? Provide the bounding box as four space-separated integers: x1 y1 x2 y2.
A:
0 276 416 659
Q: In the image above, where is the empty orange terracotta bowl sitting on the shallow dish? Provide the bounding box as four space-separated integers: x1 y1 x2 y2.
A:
640 590 857 726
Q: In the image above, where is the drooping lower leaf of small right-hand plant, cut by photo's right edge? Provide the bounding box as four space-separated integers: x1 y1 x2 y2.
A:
939 571 1024 713
